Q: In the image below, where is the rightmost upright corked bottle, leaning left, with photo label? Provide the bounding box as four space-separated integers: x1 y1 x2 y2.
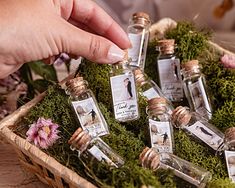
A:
182 60 212 119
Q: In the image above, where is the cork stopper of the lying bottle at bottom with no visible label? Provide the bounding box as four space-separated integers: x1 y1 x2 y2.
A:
139 147 160 170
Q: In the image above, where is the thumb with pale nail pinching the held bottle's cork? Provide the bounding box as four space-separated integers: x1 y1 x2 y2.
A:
60 24 125 63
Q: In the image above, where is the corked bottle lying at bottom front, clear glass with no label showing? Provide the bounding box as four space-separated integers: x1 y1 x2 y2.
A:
140 147 211 188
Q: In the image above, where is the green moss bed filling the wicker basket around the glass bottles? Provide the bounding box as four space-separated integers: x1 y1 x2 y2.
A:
16 22 235 188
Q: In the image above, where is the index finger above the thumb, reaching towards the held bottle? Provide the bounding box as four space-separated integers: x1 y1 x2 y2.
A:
71 0 131 49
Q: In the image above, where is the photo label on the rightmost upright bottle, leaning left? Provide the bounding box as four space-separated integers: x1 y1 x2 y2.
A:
188 77 212 119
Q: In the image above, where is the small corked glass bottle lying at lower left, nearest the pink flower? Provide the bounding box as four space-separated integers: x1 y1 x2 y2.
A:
68 128 124 168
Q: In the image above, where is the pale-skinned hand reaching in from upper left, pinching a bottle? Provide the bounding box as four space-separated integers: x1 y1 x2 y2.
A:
0 0 130 78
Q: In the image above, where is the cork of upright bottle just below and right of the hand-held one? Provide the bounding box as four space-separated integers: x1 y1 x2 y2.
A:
148 97 168 115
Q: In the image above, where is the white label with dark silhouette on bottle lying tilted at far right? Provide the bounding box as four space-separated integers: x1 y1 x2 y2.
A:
185 121 223 151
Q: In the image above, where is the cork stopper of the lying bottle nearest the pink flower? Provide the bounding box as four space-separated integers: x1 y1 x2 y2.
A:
68 128 91 153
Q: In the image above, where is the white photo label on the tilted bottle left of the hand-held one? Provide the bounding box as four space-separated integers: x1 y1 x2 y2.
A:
72 97 109 136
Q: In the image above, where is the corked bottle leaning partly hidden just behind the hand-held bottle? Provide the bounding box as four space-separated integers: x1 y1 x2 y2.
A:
134 69 174 114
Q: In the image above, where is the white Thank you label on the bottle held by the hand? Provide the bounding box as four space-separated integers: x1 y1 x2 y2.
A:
110 72 139 120
